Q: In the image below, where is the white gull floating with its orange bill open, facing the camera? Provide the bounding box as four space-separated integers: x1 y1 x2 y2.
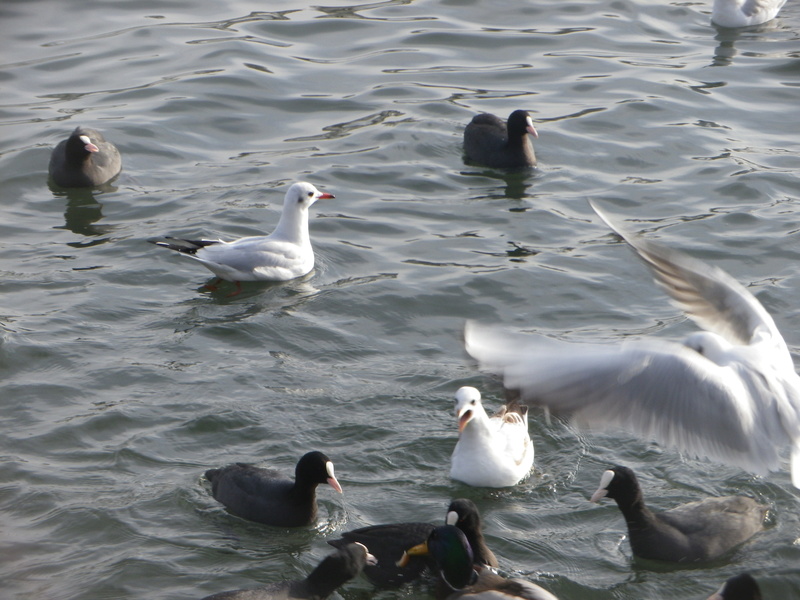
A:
450 386 533 487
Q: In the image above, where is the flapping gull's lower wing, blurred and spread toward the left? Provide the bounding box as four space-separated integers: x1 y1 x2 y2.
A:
464 322 787 474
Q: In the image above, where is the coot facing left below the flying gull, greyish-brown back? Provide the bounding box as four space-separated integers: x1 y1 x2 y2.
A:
591 466 767 563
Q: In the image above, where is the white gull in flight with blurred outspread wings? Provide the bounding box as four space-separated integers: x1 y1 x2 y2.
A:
465 205 800 488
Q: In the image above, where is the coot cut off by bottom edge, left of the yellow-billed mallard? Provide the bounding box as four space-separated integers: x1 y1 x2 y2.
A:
198 543 375 600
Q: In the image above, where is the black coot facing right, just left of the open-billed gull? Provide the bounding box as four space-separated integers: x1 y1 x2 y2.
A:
205 452 342 527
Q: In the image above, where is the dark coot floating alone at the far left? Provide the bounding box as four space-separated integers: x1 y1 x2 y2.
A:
48 127 122 187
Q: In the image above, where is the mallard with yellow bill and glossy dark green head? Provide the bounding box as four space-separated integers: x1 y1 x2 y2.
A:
400 525 558 600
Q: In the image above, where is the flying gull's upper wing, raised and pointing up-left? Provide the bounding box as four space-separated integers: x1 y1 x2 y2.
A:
590 202 789 356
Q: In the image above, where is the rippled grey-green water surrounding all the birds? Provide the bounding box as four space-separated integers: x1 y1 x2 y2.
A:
0 0 800 600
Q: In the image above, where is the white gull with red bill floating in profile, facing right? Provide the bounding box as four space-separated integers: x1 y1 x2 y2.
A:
150 181 334 293
